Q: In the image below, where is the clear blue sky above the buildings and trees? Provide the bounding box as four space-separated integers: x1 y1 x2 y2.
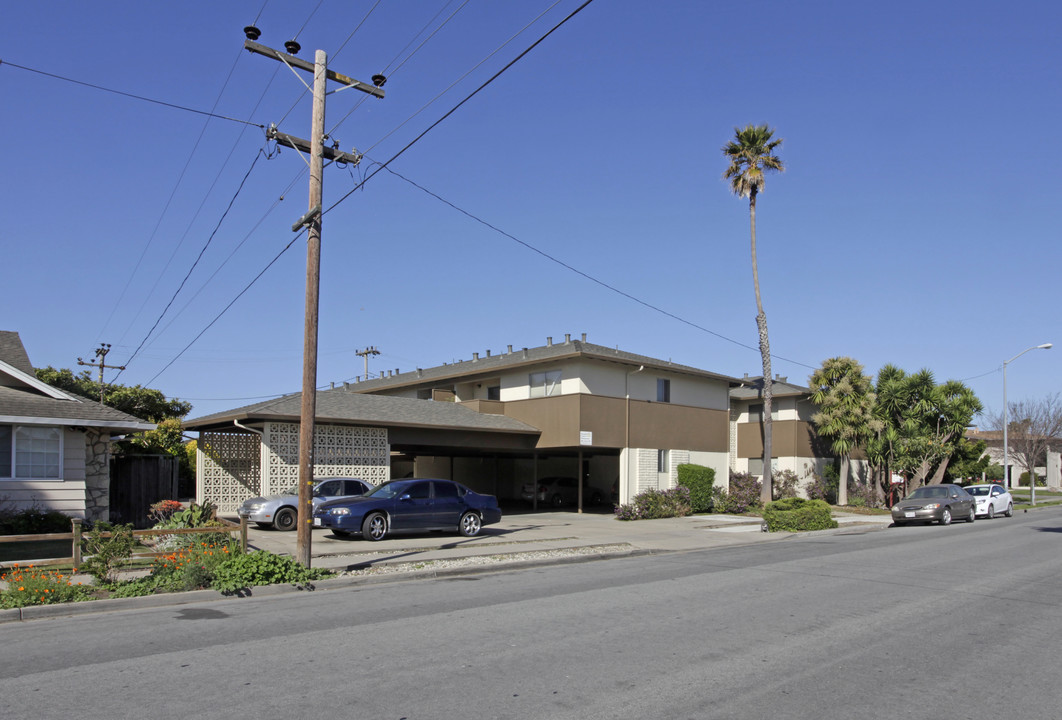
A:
0 0 1062 416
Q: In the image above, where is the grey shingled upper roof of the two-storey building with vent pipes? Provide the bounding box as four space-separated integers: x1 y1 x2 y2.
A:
346 340 740 393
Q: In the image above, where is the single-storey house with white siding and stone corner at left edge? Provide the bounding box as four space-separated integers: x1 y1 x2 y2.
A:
0 330 155 519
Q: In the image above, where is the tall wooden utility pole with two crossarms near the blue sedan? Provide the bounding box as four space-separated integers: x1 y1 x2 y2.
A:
243 29 384 567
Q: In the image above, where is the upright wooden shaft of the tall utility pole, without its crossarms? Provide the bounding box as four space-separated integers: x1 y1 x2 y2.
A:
295 50 328 567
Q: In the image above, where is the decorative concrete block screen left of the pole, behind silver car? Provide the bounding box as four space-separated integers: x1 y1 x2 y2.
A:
195 432 261 513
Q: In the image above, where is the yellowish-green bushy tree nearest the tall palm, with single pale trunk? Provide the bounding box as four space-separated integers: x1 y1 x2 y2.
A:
808 358 885 505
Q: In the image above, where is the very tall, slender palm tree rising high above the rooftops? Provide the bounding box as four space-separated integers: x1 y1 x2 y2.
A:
723 124 785 504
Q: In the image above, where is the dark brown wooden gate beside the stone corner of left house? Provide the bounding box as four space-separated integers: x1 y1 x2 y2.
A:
110 455 178 530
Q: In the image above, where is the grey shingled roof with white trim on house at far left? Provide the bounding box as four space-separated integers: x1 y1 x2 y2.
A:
0 330 155 432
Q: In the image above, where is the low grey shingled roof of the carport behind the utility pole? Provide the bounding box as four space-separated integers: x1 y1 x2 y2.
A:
183 388 539 434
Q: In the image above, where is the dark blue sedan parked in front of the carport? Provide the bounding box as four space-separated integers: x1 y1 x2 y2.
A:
313 478 501 541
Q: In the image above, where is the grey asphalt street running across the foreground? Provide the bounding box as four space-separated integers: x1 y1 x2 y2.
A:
0 509 1062 720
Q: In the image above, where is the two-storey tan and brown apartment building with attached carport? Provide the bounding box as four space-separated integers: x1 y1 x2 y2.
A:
184 336 738 512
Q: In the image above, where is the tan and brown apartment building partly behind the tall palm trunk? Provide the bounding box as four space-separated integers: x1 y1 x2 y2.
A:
730 375 836 488
